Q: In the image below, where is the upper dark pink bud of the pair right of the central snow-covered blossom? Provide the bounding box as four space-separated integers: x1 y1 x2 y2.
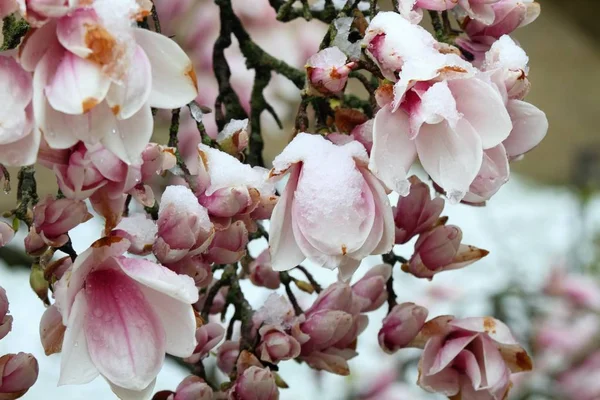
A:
394 176 444 244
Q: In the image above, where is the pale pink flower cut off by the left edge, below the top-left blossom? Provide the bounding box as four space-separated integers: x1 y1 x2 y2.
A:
0 55 40 166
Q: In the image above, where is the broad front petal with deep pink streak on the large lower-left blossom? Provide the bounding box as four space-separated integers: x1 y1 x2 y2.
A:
84 270 165 391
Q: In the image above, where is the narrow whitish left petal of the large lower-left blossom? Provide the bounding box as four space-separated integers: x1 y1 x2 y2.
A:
58 291 98 385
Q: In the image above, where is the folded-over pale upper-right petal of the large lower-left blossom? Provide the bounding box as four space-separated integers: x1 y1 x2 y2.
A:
118 257 198 304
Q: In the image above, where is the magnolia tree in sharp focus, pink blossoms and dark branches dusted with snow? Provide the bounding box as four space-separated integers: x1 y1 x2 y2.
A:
0 0 548 400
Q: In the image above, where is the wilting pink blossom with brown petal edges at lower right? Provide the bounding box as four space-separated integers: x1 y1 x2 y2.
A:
411 316 532 400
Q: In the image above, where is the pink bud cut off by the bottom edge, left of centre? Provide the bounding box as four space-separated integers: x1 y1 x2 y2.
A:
229 366 279 400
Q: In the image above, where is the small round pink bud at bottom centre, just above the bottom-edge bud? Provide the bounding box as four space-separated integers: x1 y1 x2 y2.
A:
257 325 300 364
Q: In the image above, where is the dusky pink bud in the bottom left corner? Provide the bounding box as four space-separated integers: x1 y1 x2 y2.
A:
0 353 39 400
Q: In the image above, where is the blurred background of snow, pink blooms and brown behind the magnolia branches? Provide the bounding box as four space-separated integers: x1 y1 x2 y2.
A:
0 0 600 400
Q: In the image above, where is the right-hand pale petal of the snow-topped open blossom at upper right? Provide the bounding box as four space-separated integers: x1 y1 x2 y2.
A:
448 78 512 149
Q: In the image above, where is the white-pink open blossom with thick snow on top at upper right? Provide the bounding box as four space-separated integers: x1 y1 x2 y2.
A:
365 13 512 202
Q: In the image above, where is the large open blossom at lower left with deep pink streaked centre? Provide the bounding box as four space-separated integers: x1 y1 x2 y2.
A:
55 237 198 399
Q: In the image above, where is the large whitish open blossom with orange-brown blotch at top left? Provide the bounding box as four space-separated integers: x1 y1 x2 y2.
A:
20 0 197 164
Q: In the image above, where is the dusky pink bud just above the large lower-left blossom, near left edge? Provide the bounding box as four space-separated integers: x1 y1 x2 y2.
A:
25 195 92 254
